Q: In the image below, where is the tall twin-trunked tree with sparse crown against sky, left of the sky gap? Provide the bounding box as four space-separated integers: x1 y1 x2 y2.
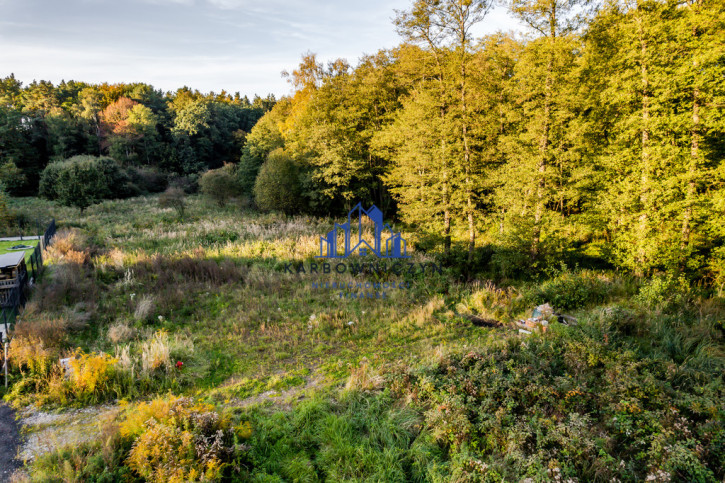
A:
388 0 492 260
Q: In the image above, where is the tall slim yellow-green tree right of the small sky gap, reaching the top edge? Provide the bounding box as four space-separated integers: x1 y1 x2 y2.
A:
499 0 585 258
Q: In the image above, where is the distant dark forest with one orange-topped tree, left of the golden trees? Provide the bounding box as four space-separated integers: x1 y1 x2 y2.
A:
0 74 276 195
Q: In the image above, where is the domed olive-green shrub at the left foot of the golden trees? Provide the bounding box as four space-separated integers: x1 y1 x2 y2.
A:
254 148 302 214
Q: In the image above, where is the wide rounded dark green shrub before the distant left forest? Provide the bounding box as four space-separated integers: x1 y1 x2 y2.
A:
40 155 128 212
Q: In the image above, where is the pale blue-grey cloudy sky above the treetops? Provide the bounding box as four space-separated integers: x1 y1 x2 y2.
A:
0 0 524 98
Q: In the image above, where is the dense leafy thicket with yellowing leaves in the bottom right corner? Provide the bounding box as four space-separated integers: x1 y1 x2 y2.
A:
386 324 723 481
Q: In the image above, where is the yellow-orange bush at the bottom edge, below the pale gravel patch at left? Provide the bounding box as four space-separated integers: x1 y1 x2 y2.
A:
23 396 236 482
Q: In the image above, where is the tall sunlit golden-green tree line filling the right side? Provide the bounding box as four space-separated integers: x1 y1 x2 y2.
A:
239 0 725 280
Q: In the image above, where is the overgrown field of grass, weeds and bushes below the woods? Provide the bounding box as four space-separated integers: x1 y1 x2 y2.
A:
4 197 725 481
